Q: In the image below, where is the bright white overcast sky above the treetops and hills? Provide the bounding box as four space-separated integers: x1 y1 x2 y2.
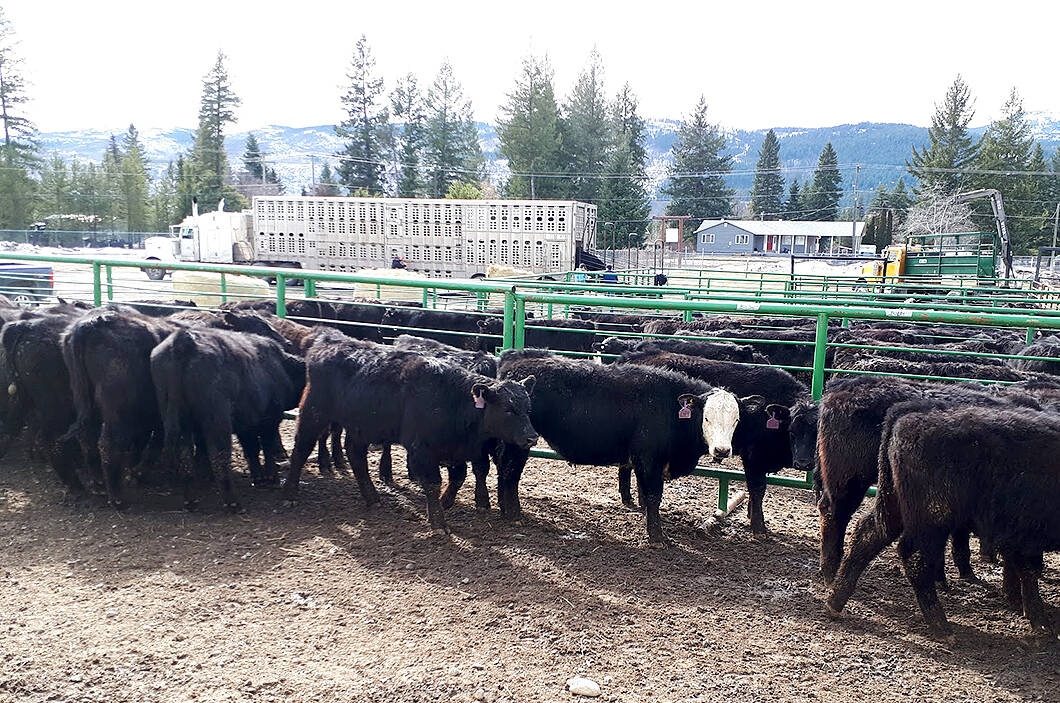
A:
0 0 1060 131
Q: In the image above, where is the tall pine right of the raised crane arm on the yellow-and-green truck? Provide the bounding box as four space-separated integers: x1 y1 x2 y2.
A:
975 88 1034 252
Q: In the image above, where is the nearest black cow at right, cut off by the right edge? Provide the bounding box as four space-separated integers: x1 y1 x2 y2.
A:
827 402 1060 639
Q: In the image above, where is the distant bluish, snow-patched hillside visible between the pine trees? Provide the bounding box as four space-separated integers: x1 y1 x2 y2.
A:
40 113 1060 211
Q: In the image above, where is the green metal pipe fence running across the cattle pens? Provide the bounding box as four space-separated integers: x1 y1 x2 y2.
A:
0 254 1060 519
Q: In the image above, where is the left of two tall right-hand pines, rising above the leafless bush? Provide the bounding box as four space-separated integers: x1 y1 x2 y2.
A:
905 75 978 194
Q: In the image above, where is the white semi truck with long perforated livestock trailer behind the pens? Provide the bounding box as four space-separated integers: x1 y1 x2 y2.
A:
145 195 602 279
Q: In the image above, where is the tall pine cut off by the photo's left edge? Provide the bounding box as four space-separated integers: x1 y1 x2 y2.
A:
0 7 38 228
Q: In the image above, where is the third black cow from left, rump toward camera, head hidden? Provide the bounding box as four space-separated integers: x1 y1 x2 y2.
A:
151 329 305 510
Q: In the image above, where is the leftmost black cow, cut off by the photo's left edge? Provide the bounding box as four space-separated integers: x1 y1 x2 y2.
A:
0 314 87 493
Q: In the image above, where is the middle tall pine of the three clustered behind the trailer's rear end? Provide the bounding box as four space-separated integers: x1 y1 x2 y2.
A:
560 49 612 203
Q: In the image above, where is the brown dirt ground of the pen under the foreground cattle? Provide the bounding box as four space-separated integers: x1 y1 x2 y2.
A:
0 428 1060 703
